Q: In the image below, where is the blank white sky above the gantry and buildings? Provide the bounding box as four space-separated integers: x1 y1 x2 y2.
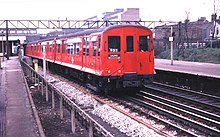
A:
0 0 220 21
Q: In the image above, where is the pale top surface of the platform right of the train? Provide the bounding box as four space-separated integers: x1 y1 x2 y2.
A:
155 59 220 78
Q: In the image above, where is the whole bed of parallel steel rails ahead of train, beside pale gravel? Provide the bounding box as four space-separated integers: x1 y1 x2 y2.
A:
103 83 220 136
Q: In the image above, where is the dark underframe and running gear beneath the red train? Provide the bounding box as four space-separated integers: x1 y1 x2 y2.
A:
36 60 153 93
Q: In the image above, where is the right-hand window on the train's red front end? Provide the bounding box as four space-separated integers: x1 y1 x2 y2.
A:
139 36 150 52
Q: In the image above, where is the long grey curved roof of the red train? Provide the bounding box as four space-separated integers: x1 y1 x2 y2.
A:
27 24 150 44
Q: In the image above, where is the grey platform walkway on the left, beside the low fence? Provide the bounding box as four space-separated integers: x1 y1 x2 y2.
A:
0 57 39 137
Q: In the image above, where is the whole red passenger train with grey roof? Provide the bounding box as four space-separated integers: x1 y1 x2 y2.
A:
26 25 155 91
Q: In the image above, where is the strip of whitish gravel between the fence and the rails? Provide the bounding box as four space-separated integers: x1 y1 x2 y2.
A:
40 75 161 137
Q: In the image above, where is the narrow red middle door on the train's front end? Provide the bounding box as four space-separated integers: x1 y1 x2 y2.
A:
122 33 137 73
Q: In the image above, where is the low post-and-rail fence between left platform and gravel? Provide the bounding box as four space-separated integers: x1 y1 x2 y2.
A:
20 60 113 137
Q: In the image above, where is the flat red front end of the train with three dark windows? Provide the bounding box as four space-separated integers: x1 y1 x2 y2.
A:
103 27 154 88
